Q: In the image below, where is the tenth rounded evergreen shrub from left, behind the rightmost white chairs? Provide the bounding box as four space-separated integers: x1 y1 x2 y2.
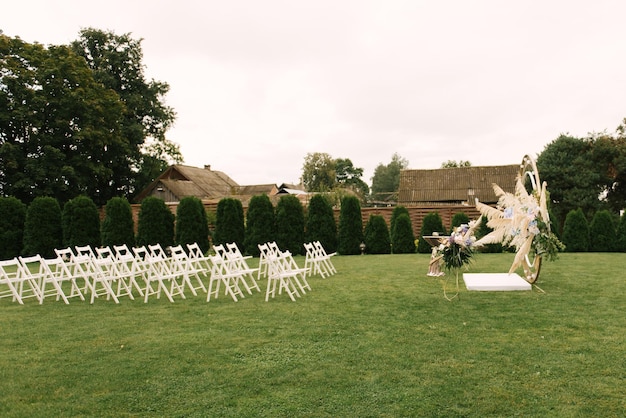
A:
305 194 337 253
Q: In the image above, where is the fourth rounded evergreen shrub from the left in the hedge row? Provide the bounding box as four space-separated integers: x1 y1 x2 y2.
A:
101 197 135 248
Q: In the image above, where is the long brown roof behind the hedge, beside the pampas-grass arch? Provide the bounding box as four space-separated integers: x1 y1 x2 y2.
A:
398 164 520 205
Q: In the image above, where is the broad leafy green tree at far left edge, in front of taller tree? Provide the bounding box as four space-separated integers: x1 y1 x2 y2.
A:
0 34 129 204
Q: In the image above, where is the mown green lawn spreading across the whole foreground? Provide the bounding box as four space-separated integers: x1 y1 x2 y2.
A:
0 254 626 417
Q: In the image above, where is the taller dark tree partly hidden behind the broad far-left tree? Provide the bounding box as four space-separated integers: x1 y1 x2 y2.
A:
71 28 182 201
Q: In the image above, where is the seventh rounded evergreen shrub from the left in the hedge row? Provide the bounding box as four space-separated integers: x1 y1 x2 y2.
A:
213 197 246 251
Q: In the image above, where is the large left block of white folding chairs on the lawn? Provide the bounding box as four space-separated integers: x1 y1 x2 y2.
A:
0 244 208 304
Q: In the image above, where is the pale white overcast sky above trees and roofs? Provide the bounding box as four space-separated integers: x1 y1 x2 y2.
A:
0 0 626 185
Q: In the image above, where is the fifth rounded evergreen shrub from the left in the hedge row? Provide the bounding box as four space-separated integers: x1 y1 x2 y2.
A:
137 196 174 249
